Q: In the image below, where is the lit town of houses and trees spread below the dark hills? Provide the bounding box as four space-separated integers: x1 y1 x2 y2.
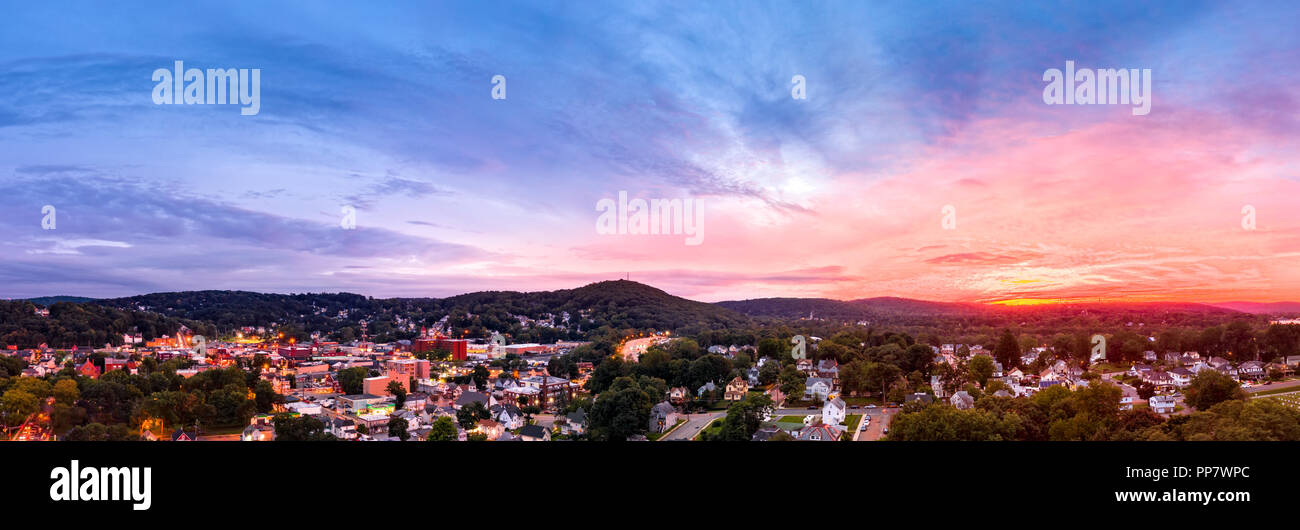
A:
0 281 1300 442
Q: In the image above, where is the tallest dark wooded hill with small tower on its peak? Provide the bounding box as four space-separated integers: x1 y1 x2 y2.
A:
96 281 749 342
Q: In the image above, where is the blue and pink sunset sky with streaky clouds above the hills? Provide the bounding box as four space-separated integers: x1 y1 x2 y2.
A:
0 0 1300 303
